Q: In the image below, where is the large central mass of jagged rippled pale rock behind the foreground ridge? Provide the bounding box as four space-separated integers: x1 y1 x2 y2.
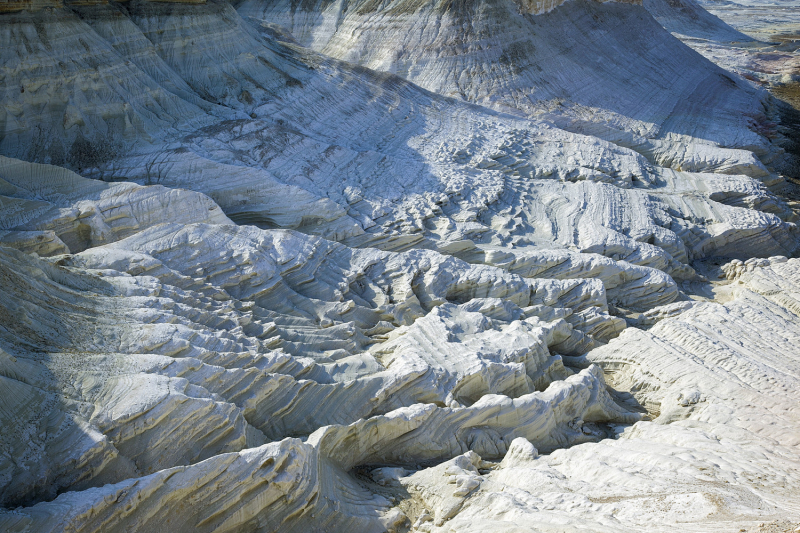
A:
0 178 637 505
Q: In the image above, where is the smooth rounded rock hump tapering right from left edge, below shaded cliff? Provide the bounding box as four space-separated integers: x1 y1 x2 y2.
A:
0 156 232 256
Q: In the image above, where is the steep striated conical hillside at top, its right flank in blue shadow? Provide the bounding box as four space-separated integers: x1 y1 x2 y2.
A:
238 0 780 175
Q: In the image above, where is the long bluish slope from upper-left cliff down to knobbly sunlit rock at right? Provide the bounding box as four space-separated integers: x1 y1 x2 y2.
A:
0 2 798 270
